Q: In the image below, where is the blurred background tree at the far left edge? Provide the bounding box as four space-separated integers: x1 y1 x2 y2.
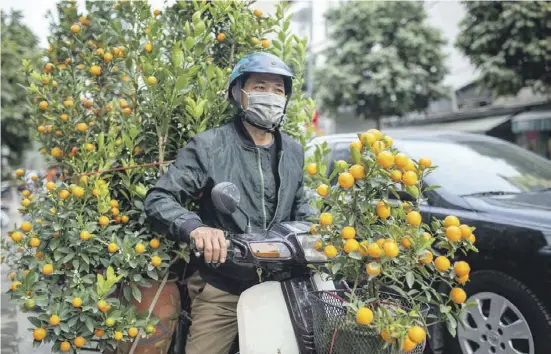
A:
1 11 38 179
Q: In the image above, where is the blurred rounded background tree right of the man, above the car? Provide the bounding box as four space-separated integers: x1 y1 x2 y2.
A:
316 1 447 126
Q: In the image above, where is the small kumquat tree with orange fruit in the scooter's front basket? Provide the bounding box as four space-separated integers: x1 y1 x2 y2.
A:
306 129 477 353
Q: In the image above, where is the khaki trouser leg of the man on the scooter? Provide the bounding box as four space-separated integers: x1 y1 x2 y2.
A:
186 272 239 354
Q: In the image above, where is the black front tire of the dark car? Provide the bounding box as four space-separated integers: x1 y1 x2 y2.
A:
444 270 551 354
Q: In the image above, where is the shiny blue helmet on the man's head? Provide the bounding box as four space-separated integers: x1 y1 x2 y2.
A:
228 52 294 107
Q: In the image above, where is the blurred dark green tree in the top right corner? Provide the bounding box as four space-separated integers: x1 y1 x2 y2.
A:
455 1 551 95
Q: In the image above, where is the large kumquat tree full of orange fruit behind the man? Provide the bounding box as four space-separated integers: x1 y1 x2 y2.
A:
3 1 314 353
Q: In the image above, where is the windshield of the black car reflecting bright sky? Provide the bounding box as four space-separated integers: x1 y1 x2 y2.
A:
397 139 551 195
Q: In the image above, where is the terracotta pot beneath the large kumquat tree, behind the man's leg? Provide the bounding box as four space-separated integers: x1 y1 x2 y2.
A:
108 280 181 354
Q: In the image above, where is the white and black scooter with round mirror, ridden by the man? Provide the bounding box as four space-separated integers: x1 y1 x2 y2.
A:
169 182 338 354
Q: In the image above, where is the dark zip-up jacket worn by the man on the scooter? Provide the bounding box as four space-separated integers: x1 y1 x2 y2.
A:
145 118 312 294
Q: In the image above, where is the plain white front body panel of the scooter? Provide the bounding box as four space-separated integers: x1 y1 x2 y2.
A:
237 274 335 354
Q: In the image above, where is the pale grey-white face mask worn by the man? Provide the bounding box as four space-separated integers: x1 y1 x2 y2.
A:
242 90 287 130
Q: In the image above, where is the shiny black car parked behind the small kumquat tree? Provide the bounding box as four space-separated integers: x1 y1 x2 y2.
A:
307 130 551 354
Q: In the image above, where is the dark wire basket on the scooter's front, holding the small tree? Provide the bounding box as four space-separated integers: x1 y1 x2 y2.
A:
309 291 430 354
